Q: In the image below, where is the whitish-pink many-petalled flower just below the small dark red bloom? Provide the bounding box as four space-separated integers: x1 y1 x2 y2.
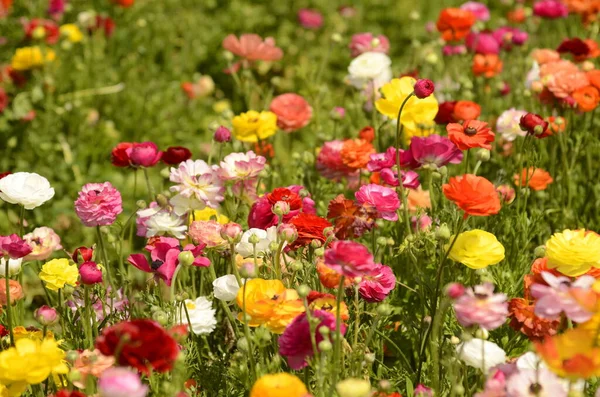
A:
170 160 225 215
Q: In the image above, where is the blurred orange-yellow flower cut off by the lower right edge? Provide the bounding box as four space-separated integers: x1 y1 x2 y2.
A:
534 320 600 380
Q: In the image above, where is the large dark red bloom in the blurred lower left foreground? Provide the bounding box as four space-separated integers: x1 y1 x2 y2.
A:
96 319 179 375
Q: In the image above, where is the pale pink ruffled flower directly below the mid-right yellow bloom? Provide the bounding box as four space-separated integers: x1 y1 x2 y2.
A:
453 283 508 331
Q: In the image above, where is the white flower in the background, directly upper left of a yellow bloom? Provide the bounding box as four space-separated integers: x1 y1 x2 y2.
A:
348 52 392 89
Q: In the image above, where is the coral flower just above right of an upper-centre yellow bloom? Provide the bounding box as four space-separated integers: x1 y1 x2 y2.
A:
269 93 312 132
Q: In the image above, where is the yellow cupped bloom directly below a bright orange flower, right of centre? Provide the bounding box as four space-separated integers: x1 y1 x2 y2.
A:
445 229 504 269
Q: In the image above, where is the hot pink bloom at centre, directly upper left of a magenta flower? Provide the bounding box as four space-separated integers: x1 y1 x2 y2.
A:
324 240 377 279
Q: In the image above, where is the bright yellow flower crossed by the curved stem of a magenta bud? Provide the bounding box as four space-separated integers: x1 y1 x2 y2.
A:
375 76 438 131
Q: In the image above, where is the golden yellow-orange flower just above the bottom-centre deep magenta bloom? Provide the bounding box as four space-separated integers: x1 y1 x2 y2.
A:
236 278 304 334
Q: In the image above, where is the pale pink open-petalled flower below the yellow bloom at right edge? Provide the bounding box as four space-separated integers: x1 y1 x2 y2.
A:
531 272 596 323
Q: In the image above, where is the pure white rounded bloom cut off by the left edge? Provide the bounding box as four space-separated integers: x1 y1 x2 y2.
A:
0 172 54 210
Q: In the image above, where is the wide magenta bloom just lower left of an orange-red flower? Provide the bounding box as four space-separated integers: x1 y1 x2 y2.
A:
403 134 463 169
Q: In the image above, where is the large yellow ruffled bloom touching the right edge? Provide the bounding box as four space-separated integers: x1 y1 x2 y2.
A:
546 229 600 277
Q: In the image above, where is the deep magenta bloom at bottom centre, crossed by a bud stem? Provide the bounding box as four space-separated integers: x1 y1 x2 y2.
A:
279 310 346 370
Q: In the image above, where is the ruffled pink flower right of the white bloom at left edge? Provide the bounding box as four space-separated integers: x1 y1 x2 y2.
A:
75 182 123 226
